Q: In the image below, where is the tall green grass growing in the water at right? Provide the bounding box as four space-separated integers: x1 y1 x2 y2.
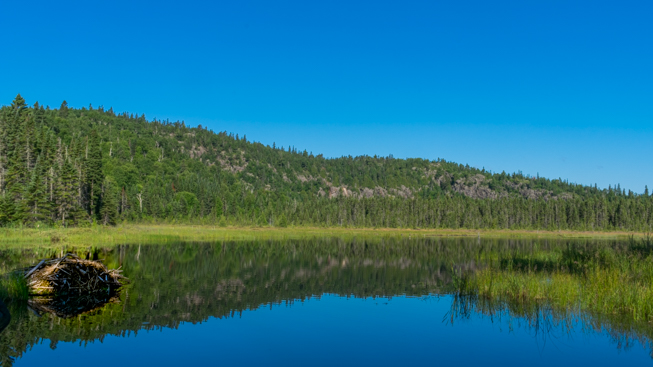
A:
459 236 653 322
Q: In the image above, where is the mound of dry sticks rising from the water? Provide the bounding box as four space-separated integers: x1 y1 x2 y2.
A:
22 254 127 295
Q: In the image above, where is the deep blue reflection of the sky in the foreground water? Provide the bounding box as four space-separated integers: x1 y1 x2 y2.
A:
15 295 651 367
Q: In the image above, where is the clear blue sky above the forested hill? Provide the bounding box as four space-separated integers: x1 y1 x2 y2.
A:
0 0 653 192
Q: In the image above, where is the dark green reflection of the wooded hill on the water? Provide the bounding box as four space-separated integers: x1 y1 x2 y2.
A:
0 238 640 366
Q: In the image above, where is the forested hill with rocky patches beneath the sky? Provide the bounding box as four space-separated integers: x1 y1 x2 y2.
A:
0 95 653 230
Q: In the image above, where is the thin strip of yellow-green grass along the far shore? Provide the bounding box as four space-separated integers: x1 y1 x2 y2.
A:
0 224 644 248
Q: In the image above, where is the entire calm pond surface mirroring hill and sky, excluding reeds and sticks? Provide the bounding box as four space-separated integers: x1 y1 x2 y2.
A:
0 239 652 367
